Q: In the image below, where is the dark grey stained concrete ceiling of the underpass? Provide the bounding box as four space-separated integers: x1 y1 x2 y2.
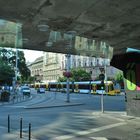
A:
0 0 140 54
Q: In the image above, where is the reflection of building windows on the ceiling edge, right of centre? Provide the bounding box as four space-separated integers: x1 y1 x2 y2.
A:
48 31 113 59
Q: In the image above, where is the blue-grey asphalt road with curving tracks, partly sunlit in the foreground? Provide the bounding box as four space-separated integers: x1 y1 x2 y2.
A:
0 90 131 140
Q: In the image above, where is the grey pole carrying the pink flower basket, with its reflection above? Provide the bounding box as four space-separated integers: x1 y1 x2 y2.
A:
66 31 76 102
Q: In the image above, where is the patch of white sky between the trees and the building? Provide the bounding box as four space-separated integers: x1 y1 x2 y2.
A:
23 50 43 62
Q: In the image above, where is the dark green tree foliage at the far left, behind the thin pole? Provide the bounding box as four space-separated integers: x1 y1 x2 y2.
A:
0 48 30 84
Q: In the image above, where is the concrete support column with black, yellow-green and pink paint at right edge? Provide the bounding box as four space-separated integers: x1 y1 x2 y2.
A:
111 52 140 117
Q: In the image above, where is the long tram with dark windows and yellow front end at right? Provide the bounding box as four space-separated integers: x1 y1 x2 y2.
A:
48 81 120 95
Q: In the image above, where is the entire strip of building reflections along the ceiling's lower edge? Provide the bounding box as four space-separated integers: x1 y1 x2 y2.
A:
0 20 113 59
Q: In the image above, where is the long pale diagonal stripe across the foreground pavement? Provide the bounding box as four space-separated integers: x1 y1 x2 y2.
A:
54 122 127 140
